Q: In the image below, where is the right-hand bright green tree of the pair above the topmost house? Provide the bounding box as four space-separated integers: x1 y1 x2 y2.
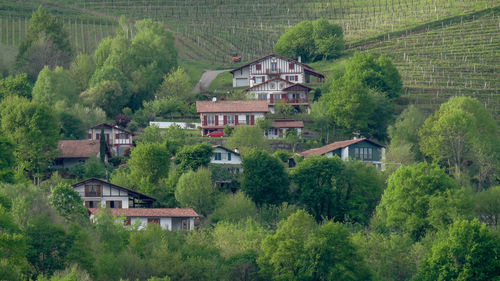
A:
312 18 344 59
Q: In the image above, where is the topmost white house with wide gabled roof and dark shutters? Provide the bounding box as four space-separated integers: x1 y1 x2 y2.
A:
230 54 324 87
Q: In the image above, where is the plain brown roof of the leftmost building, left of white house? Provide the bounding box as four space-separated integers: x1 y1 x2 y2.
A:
57 140 100 158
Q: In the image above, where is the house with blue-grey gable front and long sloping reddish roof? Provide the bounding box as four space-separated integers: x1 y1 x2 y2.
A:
299 138 385 169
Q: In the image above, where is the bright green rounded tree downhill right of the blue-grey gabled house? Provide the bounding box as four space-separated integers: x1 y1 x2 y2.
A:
377 163 457 240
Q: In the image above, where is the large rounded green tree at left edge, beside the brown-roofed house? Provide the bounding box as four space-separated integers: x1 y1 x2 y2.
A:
0 97 59 184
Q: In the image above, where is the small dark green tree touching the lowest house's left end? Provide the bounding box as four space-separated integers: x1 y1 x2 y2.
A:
50 184 86 219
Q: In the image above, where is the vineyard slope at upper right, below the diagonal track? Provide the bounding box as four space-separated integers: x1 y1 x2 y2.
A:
363 11 500 116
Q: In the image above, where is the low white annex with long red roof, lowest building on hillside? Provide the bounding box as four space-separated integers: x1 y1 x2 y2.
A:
88 208 199 230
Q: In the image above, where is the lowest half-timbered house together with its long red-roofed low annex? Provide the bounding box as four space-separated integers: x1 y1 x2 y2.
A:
72 178 199 230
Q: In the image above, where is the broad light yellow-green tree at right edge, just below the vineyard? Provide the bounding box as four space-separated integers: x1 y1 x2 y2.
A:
419 97 500 187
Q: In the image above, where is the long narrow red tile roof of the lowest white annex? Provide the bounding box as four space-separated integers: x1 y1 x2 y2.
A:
88 208 199 218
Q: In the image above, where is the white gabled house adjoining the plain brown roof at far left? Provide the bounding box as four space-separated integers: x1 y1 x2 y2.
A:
87 123 134 156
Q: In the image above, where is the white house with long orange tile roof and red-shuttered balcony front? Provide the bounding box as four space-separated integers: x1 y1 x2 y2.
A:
196 100 269 136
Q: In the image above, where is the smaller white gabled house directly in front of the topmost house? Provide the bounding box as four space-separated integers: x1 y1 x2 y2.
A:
245 77 312 113
